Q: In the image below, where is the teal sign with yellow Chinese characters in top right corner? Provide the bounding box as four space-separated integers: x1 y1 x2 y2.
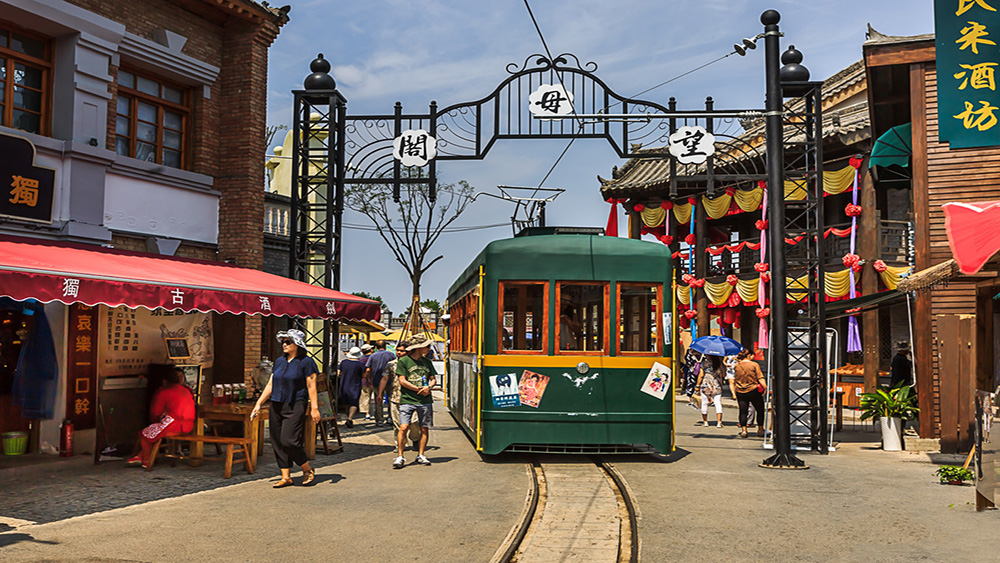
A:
934 0 1000 149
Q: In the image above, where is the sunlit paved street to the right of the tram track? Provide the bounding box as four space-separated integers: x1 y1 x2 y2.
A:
614 402 1000 562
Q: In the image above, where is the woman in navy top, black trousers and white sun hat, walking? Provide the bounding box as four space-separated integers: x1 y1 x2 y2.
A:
250 329 320 489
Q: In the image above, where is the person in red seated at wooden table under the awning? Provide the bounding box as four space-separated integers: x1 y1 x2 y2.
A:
128 368 194 467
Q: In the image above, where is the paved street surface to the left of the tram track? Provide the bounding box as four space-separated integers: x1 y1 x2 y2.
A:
0 392 528 563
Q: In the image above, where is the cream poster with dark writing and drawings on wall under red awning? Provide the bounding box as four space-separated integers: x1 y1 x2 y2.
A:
99 307 215 376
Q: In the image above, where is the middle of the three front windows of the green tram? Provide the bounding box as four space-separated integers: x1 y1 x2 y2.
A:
559 283 607 352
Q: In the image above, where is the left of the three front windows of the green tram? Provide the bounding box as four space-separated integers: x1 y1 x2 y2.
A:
500 282 546 351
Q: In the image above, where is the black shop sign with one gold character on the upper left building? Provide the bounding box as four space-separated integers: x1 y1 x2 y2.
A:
0 133 56 223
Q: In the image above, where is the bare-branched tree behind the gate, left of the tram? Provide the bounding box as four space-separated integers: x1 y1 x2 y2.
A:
344 173 475 326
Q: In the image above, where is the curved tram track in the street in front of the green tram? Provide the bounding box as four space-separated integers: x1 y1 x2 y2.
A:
491 457 639 563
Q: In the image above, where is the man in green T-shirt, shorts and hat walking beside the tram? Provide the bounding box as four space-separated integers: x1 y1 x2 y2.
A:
392 334 437 469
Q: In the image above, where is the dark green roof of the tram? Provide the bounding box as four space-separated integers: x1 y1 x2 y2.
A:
448 234 671 298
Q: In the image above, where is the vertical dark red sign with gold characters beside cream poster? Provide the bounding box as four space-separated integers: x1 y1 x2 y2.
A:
66 305 98 430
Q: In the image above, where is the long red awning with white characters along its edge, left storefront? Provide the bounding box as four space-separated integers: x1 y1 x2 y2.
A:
0 236 380 320
